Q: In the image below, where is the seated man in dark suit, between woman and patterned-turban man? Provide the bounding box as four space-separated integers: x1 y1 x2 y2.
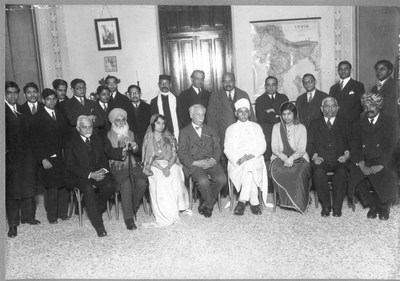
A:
307 97 351 217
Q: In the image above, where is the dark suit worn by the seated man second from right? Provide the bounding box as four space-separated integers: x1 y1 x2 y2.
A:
307 117 351 210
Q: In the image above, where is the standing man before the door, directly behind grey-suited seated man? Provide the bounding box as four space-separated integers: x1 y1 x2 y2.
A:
179 69 211 127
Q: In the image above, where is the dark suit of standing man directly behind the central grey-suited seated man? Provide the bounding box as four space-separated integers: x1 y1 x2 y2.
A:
178 86 211 127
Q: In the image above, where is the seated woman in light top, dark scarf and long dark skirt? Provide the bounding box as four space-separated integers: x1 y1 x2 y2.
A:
271 102 310 214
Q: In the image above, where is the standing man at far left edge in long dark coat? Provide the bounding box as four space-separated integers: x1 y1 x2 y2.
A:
5 81 40 238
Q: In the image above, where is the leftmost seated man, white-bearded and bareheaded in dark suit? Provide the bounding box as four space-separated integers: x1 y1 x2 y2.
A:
67 115 114 237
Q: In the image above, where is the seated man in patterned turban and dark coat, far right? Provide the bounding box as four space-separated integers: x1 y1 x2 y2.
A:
349 93 396 220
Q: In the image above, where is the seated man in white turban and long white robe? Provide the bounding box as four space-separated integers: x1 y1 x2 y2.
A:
224 99 268 215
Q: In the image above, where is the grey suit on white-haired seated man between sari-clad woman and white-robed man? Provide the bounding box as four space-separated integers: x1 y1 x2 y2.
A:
178 124 227 210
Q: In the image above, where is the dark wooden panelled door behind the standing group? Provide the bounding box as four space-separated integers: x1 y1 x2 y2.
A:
159 6 232 95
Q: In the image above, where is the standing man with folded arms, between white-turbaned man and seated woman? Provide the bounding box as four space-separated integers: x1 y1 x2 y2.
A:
256 76 289 161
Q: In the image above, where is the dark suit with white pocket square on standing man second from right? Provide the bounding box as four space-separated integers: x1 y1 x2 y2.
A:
329 78 365 124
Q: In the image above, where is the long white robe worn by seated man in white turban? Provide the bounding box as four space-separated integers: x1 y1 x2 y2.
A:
224 120 268 204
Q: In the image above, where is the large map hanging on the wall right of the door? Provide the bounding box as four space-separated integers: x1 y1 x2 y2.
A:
250 18 321 100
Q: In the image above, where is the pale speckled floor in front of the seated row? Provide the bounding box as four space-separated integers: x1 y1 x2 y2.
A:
5 192 400 279
